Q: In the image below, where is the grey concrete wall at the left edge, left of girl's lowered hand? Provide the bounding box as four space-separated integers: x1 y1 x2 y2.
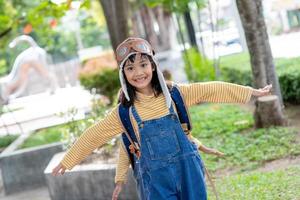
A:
0 143 62 194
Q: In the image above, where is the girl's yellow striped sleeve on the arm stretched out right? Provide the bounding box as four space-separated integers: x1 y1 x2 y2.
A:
179 81 253 106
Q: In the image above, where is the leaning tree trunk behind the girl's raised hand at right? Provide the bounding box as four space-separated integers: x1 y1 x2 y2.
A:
236 0 283 105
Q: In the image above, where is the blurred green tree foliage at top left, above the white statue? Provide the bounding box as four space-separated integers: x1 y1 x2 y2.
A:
0 0 110 72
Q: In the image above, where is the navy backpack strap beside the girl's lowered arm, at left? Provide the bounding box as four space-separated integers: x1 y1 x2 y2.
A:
118 104 140 169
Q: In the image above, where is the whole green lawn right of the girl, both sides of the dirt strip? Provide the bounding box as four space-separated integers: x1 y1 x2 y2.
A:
190 104 300 200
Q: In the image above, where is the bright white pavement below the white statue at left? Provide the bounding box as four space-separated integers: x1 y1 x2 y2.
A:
0 87 92 135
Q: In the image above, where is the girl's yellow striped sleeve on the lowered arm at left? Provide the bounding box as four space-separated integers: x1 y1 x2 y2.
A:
61 107 123 170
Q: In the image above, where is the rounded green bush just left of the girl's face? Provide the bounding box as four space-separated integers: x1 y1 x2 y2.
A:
79 68 120 104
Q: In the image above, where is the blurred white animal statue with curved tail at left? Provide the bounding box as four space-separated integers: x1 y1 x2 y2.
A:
0 35 57 102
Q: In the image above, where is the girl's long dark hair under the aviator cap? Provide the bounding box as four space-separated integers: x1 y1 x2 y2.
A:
119 54 162 107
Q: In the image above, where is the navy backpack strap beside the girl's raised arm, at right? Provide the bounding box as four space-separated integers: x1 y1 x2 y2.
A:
170 85 192 133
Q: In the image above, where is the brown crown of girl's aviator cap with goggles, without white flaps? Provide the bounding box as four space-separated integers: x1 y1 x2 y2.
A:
116 38 153 64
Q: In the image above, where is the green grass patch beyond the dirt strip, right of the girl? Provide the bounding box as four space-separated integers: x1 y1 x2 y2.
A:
191 104 300 170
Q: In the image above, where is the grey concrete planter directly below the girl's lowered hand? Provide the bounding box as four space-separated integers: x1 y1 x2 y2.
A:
45 154 138 200
